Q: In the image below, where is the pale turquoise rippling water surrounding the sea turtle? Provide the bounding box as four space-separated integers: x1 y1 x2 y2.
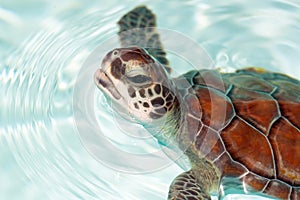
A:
0 0 300 200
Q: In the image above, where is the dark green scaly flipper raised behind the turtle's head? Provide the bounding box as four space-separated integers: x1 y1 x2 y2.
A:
118 6 171 73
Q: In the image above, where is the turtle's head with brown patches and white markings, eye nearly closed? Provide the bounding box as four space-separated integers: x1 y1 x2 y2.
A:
94 47 175 123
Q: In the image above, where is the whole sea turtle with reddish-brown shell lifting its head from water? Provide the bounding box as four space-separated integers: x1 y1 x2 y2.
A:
94 6 300 200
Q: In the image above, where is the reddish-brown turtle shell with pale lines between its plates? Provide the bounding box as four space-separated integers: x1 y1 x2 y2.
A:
177 68 300 199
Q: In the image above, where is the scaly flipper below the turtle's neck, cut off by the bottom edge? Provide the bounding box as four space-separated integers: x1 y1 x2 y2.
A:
168 170 211 200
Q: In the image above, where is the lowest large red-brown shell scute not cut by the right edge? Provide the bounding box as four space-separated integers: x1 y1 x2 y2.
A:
221 117 275 178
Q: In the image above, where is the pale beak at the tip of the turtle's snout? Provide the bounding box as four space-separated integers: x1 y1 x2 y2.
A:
94 69 122 100
